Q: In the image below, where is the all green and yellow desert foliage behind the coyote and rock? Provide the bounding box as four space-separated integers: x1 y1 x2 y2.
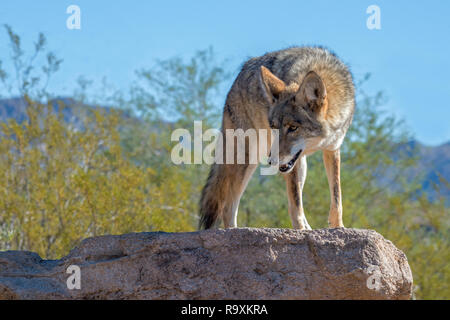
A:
0 27 450 299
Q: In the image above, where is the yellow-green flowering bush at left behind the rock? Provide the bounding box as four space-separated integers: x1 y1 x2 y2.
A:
0 28 193 258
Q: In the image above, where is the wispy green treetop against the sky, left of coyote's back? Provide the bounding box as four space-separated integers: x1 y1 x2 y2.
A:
130 48 230 128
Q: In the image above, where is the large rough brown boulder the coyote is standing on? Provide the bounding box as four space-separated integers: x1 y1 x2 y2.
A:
0 228 412 299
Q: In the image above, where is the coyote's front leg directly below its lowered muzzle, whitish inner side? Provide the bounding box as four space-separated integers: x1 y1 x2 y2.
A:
283 156 311 230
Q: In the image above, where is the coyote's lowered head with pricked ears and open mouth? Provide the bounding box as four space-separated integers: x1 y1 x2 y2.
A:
260 66 328 173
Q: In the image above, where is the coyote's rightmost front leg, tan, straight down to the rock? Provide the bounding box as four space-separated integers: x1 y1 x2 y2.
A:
323 149 344 228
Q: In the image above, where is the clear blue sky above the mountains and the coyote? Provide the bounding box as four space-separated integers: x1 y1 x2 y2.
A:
0 0 450 145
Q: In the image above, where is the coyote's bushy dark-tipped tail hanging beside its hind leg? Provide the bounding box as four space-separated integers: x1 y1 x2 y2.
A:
198 164 223 229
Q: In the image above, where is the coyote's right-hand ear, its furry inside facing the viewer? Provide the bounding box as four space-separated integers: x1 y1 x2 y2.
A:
296 71 327 111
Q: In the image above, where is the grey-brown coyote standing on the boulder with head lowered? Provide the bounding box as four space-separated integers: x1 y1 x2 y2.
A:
199 47 355 230
